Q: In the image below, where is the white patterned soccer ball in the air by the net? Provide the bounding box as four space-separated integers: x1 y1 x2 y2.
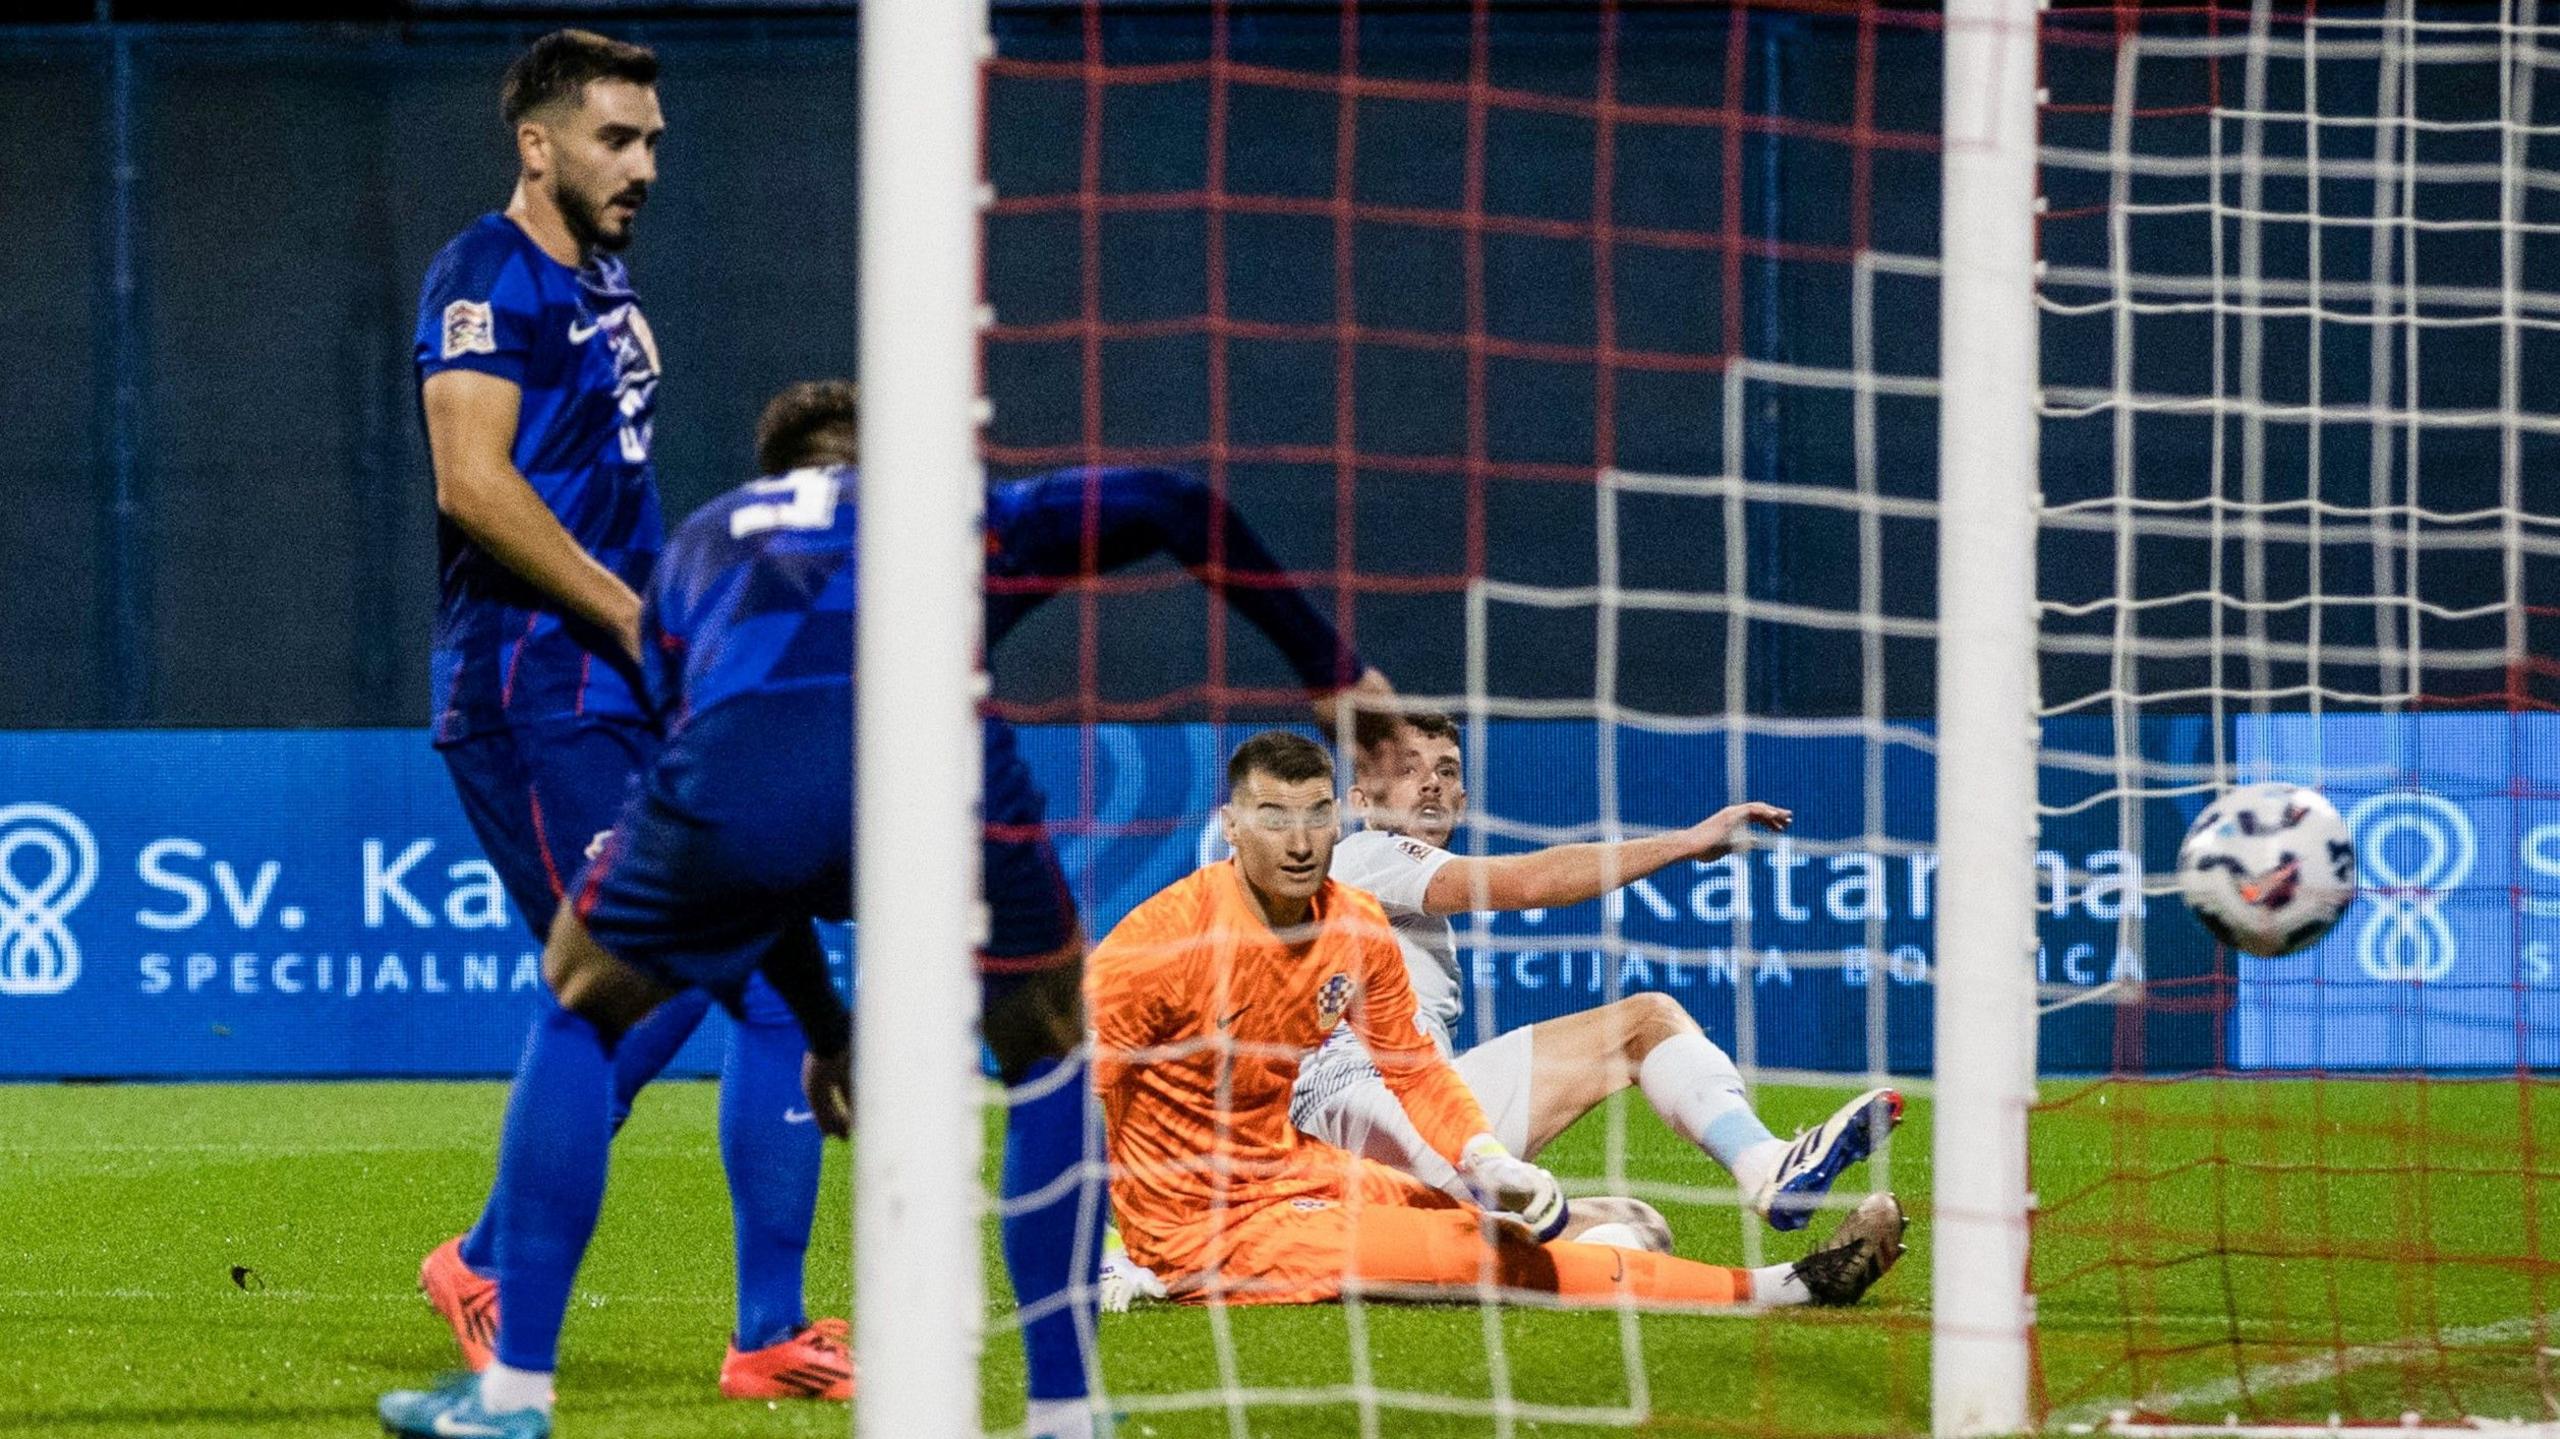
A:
2179 781 2355 955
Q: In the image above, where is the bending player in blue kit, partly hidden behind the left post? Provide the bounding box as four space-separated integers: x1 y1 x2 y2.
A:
381 384 1393 1439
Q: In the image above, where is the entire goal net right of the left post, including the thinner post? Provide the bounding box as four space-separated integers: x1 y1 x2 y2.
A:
860 0 2560 1436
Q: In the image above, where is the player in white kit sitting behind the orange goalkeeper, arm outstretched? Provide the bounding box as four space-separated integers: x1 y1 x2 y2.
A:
1290 714 1902 1229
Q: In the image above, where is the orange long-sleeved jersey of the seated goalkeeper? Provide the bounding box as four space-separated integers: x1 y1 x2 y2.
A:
1085 860 1492 1280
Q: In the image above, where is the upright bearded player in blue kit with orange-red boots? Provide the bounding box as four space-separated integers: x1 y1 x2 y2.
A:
399 31 852 1398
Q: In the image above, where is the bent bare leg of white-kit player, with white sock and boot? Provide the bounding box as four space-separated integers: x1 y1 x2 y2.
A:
1495 993 1902 1229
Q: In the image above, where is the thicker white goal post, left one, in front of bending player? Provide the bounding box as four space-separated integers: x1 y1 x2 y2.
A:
852 0 988 1434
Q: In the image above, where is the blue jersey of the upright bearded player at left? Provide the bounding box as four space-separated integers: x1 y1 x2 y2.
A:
415 215 666 743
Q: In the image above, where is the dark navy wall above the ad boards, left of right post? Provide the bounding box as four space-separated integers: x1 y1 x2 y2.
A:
0 3 1935 727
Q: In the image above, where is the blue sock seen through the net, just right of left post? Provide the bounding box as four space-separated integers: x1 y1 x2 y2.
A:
1004 1057 1103 1398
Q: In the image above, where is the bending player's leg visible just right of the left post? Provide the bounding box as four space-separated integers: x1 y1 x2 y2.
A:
978 720 1106 1439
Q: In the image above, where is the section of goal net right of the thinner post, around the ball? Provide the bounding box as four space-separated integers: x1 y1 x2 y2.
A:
2027 3 2560 1429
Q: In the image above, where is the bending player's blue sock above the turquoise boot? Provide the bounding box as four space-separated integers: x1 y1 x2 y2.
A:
486 996 614 1372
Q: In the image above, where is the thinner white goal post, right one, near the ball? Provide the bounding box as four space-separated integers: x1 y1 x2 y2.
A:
1925 0 2040 1436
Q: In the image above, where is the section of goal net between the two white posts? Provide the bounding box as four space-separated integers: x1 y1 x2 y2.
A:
962 3 1938 1434
